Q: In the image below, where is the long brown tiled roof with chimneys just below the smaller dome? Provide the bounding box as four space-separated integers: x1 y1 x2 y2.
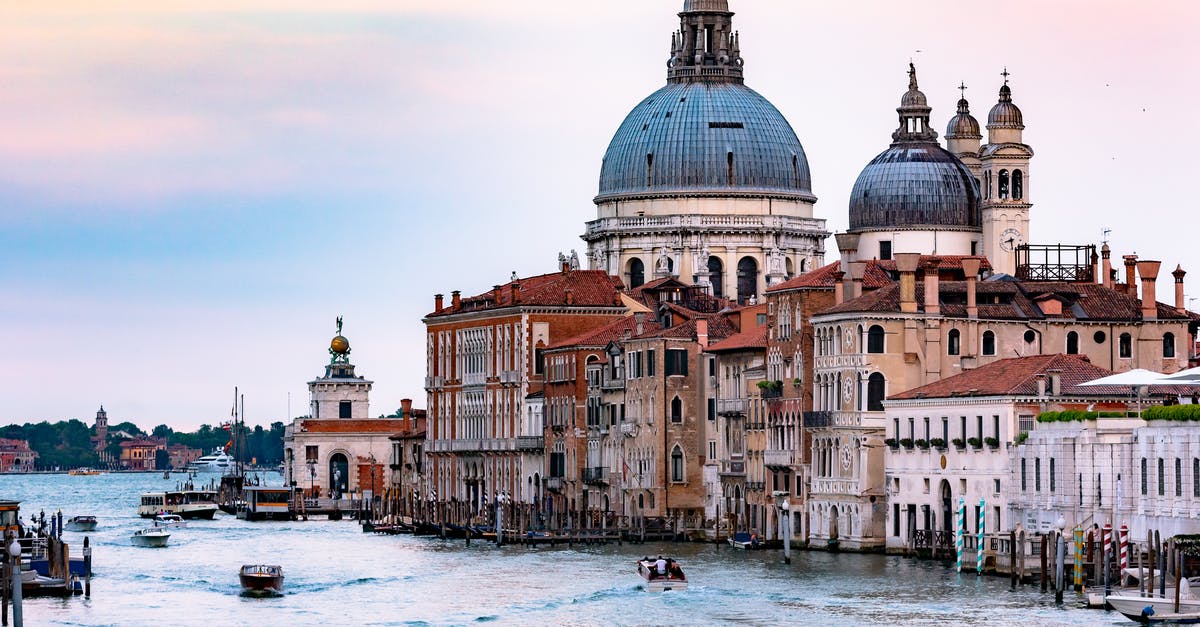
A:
821 280 1192 322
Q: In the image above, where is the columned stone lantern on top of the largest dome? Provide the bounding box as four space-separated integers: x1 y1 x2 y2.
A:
667 0 742 83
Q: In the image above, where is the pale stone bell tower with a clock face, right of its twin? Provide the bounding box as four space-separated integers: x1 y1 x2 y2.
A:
979 70 1033 274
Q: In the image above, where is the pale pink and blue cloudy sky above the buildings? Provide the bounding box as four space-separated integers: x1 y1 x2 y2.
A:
0 0 1200 429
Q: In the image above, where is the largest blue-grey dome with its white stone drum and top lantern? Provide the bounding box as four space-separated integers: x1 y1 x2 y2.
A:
582 0 829 303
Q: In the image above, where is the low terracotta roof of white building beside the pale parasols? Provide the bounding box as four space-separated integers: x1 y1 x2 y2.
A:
890 354 1108 400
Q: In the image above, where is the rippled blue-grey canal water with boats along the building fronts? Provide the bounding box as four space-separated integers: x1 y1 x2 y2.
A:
0 474 1118 627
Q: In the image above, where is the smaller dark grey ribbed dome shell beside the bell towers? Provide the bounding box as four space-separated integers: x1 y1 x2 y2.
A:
850 142 980 231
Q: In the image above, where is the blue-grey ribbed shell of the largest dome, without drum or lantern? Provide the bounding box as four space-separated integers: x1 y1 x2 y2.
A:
596 80 816 203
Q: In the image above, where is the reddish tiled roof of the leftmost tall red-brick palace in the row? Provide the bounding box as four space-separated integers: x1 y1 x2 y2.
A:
428 270 624 317
